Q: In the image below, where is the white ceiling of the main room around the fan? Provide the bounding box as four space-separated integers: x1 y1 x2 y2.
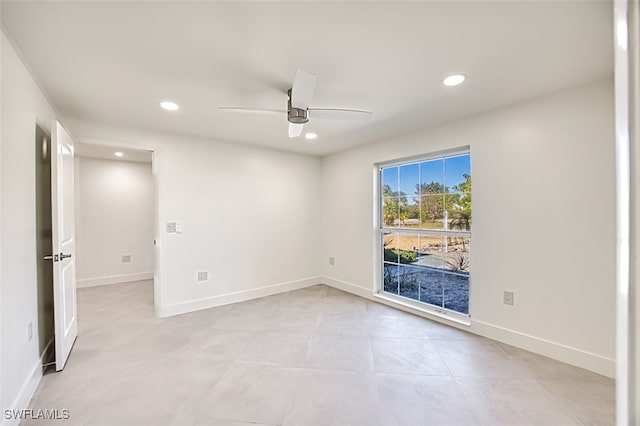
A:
2 0 613 155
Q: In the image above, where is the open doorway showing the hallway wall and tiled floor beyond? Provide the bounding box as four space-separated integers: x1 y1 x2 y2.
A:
75 143 156 336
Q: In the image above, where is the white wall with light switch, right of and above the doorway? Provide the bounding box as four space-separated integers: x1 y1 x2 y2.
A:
65 119 321 315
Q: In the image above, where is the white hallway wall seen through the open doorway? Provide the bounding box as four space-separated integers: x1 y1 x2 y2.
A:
75 157 155 287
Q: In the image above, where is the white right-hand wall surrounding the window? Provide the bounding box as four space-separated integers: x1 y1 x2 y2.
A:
321 81 616 375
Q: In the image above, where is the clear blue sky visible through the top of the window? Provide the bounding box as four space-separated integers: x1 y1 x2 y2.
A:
382 154 471 195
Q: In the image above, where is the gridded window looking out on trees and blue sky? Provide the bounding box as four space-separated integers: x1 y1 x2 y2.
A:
380 152 471 315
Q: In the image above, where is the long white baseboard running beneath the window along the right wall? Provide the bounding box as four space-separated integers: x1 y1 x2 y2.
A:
322 277 616 378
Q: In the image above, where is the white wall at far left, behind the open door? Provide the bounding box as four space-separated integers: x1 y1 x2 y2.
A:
0 34 55 424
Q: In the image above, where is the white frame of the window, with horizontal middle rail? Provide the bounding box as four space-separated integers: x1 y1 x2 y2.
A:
373 146 473 326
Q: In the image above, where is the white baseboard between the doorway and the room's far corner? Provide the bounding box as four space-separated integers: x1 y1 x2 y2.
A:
156 276 323 318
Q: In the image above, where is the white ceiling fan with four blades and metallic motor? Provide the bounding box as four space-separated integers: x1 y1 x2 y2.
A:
218 70 372 138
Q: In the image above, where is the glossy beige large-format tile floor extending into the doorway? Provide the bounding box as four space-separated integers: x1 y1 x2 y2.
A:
22 281 614 426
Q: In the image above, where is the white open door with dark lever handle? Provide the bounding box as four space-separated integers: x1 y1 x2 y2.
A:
51 121 78 371
